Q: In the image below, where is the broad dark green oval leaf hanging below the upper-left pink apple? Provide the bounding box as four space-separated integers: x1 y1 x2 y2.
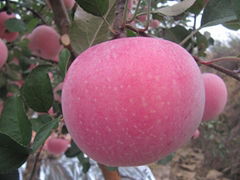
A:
22 65 53 112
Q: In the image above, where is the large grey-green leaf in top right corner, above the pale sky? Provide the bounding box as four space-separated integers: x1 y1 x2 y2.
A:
201 0 237 27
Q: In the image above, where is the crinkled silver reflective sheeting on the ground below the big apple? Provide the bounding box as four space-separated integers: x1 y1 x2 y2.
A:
19 156 155 180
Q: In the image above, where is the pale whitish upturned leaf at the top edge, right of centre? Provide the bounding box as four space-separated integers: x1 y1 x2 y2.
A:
156 0 196 16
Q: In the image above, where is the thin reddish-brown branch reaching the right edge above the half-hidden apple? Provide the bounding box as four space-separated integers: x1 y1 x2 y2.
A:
193 56 240 81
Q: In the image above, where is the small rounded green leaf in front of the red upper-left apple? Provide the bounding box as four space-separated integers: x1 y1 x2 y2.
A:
5 18 26 32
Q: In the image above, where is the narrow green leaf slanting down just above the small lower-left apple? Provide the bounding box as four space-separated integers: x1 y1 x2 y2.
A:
32 119 59 152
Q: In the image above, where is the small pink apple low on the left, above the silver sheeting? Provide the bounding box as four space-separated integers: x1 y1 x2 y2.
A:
45 137 70 155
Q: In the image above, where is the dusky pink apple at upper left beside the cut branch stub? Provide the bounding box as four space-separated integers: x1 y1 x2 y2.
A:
28 25 62 60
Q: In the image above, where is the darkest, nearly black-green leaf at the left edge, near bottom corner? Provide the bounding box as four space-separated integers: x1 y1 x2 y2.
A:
0 132 30 173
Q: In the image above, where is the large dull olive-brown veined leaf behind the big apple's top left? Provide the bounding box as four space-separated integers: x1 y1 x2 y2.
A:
70 0 116 53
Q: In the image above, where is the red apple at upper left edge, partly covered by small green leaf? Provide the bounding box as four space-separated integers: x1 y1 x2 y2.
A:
0 11 19 42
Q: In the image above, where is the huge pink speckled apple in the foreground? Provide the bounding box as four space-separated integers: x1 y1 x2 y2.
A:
62 37 205 166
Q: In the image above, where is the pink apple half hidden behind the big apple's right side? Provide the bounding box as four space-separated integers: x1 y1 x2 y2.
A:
202 73 228 121
